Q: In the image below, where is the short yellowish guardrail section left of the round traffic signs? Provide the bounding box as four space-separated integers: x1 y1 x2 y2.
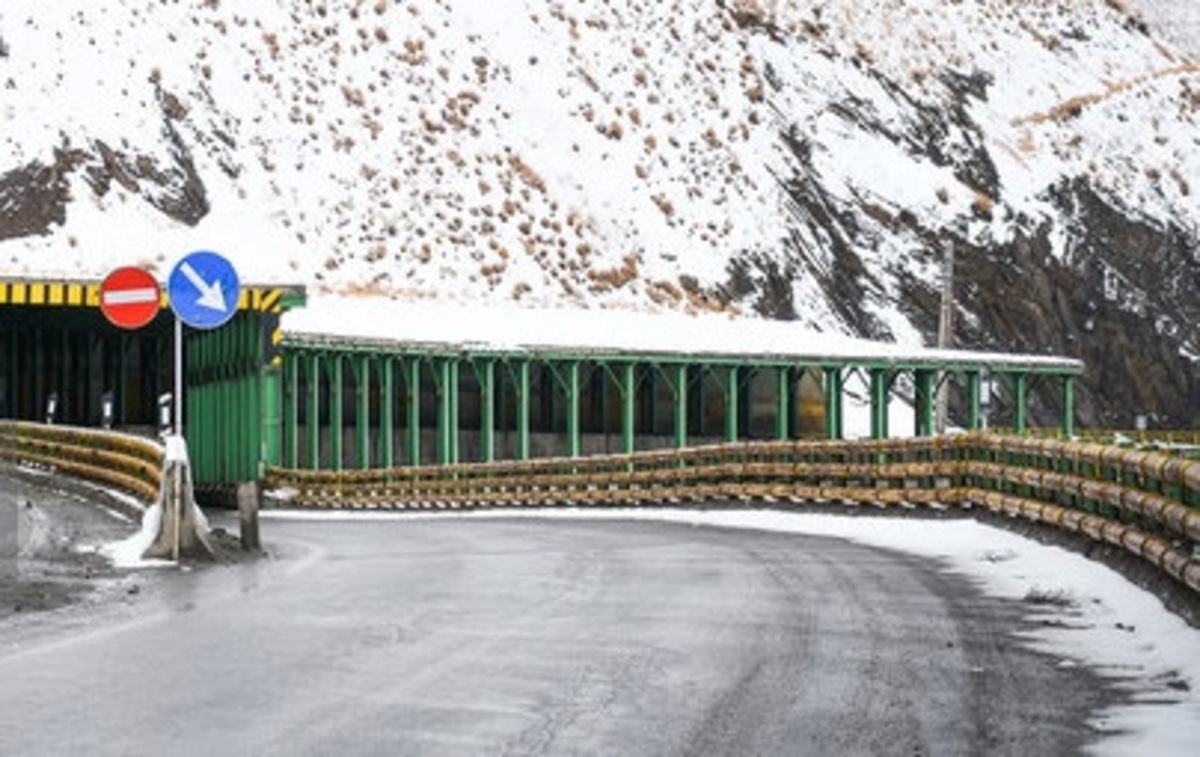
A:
0 421 163 503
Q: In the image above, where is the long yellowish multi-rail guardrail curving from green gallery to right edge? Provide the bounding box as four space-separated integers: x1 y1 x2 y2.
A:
265 433 1200 591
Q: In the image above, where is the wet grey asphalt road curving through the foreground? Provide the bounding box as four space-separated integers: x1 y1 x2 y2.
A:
0 506 1109 756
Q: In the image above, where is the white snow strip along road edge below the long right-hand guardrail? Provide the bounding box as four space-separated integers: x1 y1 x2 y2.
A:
262 507 1200 757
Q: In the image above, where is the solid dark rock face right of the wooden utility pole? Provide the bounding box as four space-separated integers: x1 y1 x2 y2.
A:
901 181 1200 428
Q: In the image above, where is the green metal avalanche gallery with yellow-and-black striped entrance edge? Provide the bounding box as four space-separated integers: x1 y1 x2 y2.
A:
0 278 1082 488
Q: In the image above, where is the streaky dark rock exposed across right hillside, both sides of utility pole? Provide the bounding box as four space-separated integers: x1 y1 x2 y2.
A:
748 59 1200 427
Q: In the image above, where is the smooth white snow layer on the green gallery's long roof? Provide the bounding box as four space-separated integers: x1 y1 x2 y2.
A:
283 296 1082 373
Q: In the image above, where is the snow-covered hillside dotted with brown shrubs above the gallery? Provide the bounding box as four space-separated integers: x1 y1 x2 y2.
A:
0 0 1200 426
